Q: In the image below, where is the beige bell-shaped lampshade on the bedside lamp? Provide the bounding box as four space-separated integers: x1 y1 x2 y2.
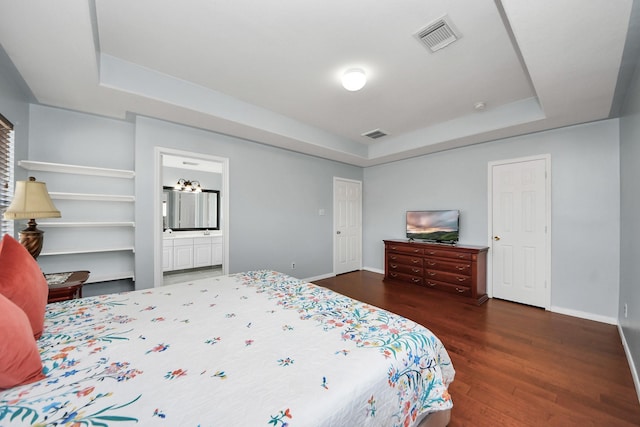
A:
4 177 60 219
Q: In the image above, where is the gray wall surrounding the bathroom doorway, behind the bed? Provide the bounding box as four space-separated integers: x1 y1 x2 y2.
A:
135 117 362 289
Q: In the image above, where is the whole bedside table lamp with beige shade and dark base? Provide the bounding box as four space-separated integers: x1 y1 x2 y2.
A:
4 176 60 259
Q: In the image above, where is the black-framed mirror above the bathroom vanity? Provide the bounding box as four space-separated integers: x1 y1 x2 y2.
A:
162 187 220 231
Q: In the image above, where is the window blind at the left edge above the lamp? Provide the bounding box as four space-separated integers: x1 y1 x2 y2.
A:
0 114 14 238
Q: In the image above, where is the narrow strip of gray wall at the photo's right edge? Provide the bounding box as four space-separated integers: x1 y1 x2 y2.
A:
618 51 640 386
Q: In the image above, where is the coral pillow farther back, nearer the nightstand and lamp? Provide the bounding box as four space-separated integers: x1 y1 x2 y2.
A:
0 234 49 339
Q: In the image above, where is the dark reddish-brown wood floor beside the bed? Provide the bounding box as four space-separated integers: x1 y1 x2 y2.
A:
314 271 640 427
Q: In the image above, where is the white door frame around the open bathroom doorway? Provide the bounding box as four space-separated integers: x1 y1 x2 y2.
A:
153 147 231 287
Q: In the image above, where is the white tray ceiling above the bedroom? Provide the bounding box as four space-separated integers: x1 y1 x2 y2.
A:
0 0 633 166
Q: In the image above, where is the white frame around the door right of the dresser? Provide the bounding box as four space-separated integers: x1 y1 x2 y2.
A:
487 154 551 310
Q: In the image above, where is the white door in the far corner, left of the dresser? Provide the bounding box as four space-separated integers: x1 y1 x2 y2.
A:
333 178 362 274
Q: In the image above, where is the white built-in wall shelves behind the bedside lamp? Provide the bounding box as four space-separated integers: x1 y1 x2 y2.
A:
18 160 135 283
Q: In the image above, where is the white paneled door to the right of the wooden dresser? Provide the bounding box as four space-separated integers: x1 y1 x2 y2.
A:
489 156 551 309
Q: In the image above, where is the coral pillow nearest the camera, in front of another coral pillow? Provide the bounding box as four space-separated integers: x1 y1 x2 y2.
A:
0 295 45 389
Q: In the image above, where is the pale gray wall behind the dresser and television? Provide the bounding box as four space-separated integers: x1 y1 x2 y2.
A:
363 120 620 322
